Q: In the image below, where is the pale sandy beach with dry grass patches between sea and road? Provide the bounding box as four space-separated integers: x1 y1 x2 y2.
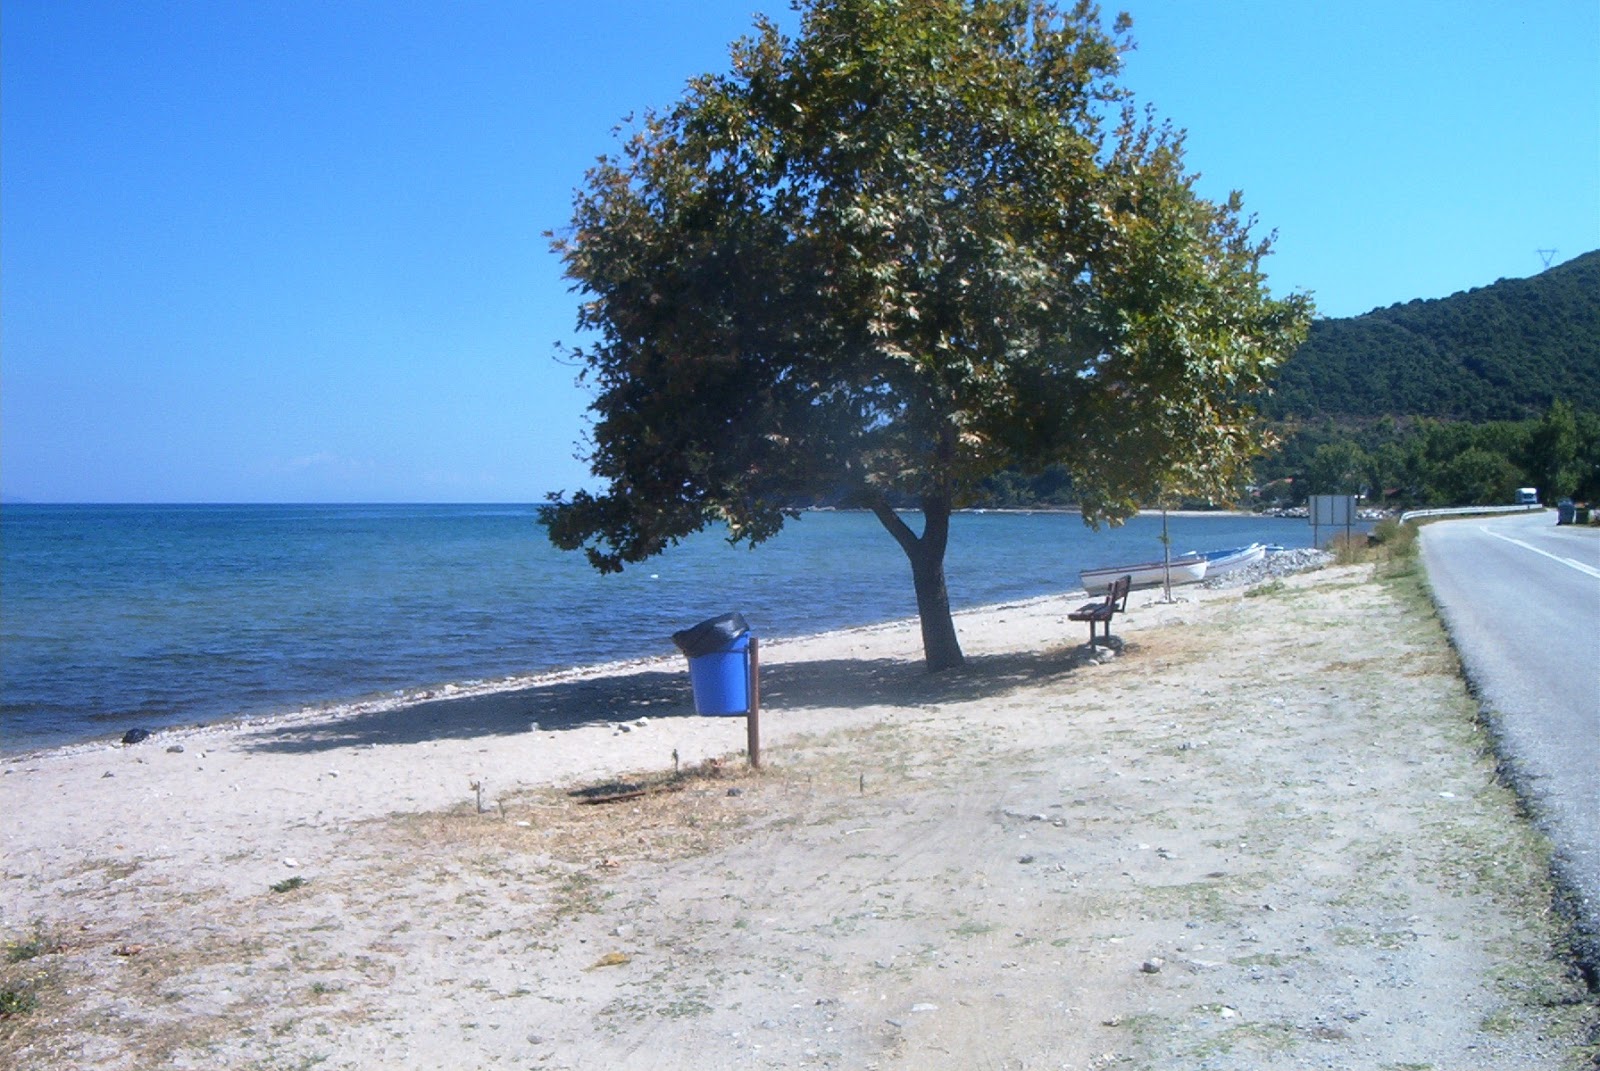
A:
0 565 1600 1071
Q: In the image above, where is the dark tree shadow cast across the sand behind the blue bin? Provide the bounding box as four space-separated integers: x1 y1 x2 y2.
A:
245 637 1122 754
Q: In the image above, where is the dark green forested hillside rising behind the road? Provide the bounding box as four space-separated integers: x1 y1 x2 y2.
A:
1262 251 1600 423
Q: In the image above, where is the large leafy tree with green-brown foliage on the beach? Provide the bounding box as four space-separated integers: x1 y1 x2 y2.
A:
542 0 1309 669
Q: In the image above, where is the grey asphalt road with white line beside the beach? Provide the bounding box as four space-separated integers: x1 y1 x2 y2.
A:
1422 512 1600 970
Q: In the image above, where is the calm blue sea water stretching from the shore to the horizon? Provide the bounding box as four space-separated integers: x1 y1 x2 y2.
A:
0 504 1310 752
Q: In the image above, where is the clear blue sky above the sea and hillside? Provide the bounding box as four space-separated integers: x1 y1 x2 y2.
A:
0 0 1600 501
